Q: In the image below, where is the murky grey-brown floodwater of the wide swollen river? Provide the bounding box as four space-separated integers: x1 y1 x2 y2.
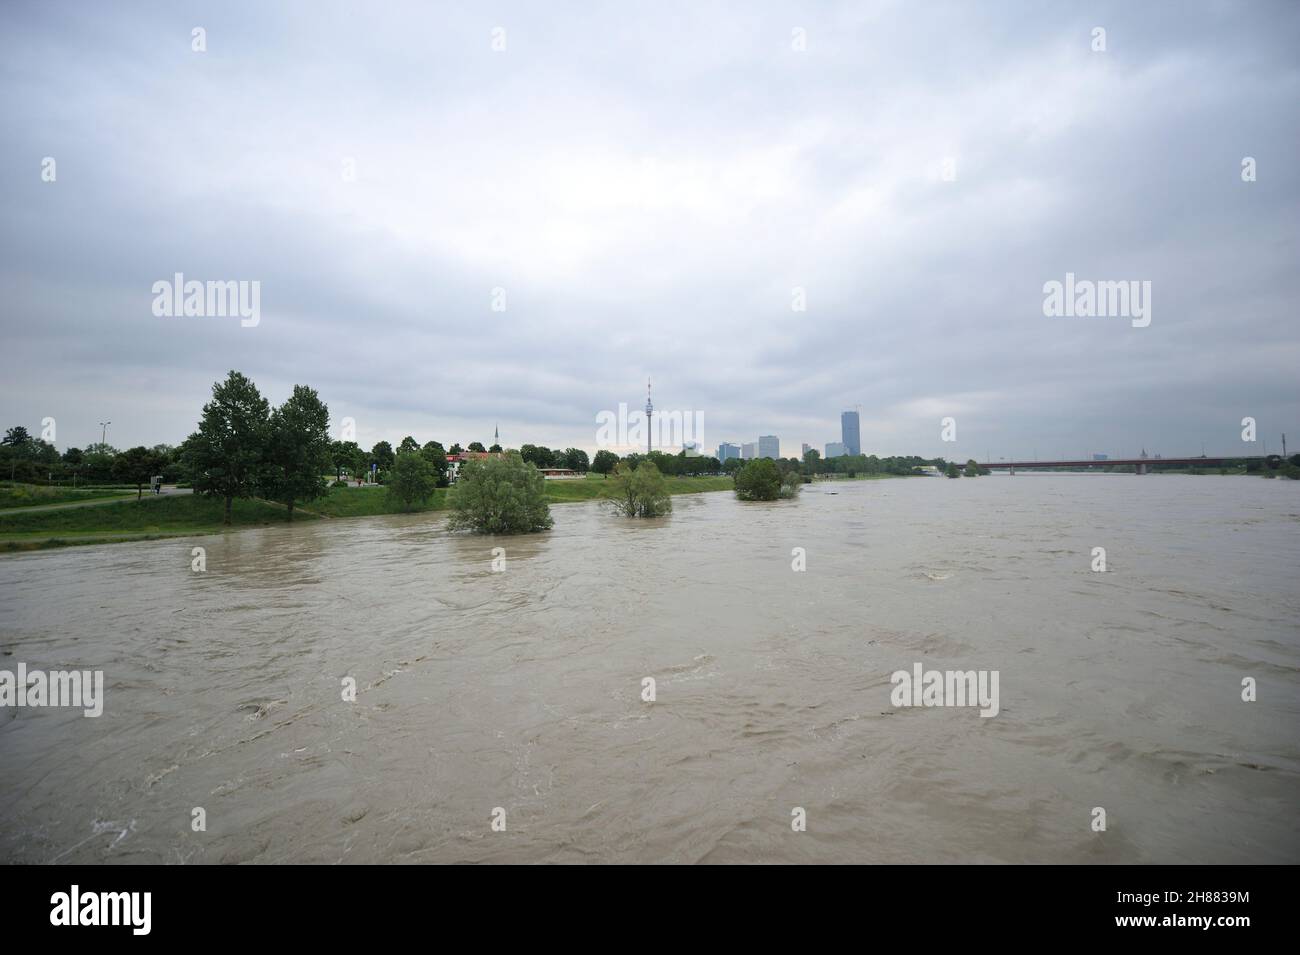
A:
0 474 1300 863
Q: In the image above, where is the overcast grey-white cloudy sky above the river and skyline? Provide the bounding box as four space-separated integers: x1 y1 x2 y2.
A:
0 0 1300 459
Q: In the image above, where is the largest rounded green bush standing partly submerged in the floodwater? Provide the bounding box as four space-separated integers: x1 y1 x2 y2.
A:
447 452 551 534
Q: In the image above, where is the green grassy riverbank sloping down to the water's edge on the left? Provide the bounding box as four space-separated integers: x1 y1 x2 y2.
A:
0 476 732 552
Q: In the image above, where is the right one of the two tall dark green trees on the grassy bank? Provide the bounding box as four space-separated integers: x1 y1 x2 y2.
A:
264 385 332 520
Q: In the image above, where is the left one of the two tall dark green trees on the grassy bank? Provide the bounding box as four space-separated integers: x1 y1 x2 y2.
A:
186 372 270 524
